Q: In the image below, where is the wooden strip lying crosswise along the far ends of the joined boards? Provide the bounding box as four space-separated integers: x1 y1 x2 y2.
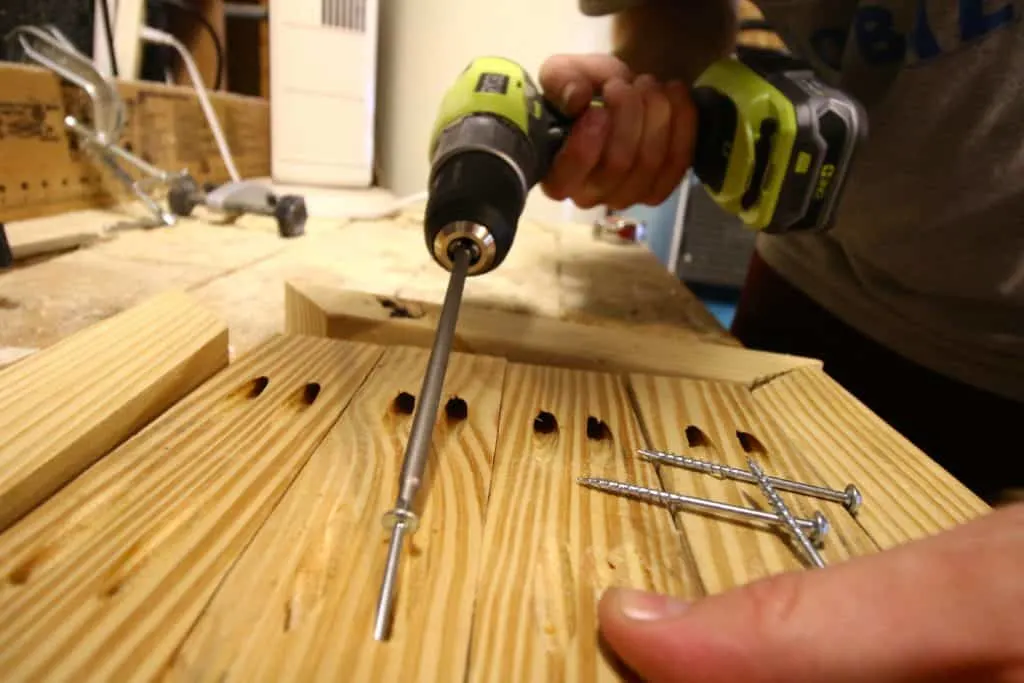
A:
285 281 821 386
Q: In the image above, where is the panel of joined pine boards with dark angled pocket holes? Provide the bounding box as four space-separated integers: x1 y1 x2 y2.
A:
0 292 987 681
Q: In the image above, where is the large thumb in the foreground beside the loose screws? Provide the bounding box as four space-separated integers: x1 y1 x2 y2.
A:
599 510 1024 683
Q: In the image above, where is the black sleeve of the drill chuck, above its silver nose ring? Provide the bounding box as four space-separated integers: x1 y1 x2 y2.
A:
424 150 526 269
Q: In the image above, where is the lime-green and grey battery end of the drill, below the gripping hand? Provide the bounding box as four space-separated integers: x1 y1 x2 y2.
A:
693 48 867 233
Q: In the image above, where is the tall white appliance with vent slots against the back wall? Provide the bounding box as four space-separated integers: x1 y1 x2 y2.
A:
269 0 379 187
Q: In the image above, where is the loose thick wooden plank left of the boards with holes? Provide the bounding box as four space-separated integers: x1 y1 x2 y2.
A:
0 293 227 530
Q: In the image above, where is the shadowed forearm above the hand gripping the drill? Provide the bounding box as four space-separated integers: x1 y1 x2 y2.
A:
580 0 737 84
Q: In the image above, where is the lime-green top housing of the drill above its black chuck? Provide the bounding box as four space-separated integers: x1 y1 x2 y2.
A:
430 57 539 153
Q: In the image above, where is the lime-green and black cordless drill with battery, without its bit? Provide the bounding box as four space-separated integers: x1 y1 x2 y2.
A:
424 48 866 275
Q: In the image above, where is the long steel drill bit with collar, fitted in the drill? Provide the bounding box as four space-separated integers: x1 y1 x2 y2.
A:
374 249 471 640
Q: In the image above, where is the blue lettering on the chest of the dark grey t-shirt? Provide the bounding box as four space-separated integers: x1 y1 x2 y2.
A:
811 0 1019 70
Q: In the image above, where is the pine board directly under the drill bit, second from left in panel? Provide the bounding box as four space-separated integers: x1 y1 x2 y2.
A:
167 348 505 681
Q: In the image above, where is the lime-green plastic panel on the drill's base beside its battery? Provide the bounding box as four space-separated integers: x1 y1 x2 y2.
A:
695 57 797 230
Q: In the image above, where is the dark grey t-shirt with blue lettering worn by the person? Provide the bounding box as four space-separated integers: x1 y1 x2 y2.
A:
580 0 1024 400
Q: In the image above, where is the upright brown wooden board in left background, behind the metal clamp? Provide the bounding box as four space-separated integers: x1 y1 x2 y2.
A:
0 63 270 222
